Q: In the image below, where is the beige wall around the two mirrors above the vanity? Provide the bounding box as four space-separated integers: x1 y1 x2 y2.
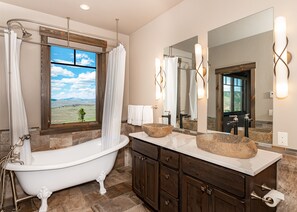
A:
129 0 297 149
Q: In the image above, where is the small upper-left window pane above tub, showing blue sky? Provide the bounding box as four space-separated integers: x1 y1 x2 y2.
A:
51 46 74 64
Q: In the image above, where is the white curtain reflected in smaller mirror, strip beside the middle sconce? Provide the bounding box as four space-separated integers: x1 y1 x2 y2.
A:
189 70 197 120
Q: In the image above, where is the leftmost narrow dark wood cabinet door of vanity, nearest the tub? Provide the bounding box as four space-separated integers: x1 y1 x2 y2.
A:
132 151 144 195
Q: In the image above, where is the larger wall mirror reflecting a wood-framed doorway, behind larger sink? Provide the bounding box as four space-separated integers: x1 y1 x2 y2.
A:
207 8 273 144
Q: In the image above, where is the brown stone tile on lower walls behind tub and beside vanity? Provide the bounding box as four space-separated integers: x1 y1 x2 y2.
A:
0 123 297 212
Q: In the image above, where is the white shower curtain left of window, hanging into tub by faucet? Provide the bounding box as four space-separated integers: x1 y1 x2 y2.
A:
4 31 31 164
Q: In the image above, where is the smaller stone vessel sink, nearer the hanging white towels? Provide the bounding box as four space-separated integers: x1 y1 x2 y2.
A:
142 123 173 138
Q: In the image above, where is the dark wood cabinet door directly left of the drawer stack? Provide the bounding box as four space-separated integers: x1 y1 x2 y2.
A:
143 157 159 210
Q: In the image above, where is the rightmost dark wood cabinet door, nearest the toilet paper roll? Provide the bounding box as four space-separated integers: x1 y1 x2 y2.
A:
208 189 245 212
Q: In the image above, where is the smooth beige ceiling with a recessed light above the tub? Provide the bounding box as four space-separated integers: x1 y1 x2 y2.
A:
0 0 183 35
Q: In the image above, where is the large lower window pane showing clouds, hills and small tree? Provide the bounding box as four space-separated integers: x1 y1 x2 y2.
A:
51 58 96 124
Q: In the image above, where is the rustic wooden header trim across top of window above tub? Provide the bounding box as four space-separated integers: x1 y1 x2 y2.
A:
39 27 107 48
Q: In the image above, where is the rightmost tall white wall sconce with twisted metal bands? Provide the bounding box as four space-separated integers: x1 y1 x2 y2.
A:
273 16 292 99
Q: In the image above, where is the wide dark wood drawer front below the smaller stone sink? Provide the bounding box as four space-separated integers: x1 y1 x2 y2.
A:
132 138 159 160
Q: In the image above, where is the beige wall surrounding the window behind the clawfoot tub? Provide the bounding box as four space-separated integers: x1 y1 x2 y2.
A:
0 2 129 130
